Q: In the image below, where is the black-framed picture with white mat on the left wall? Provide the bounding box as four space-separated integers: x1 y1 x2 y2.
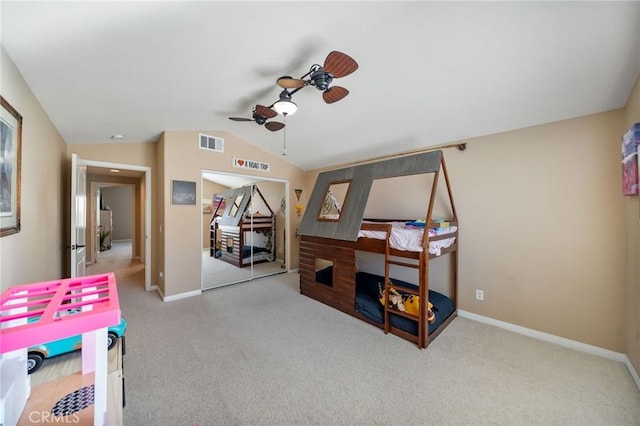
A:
0 96 22 237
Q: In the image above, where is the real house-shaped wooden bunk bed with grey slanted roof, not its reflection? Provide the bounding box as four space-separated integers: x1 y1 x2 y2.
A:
298 151 458 348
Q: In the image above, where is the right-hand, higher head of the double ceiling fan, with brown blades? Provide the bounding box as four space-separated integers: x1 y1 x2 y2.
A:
277 50 358 104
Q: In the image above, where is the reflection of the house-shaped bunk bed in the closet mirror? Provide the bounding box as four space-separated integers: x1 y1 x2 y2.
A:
210 185 276 268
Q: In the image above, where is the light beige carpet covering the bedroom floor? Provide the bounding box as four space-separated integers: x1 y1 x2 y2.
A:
91 256 640 426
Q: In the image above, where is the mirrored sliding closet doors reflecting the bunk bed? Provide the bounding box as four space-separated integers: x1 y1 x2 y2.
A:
201 170 289 291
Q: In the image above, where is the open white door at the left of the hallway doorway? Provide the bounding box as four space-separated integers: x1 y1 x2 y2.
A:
70 154 87 278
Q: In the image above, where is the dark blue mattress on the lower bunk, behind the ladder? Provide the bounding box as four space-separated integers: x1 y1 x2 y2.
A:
356 272 455 336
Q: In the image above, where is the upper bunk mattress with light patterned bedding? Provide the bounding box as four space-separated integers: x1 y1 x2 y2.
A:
358 222 458 256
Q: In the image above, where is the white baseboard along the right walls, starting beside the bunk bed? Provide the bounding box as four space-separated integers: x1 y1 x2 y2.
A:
458 309 640 390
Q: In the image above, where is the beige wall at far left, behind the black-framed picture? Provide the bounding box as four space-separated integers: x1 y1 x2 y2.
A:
0 47 70 290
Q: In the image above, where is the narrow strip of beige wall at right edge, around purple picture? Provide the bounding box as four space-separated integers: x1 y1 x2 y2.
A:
620 76 640 372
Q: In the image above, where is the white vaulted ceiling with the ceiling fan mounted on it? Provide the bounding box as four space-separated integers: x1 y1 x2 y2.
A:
0 0 640 169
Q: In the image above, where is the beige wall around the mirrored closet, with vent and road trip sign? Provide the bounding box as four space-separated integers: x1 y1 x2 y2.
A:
158 131 306 296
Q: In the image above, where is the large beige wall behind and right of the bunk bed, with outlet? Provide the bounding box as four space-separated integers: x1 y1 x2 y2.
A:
310 111 624 352
